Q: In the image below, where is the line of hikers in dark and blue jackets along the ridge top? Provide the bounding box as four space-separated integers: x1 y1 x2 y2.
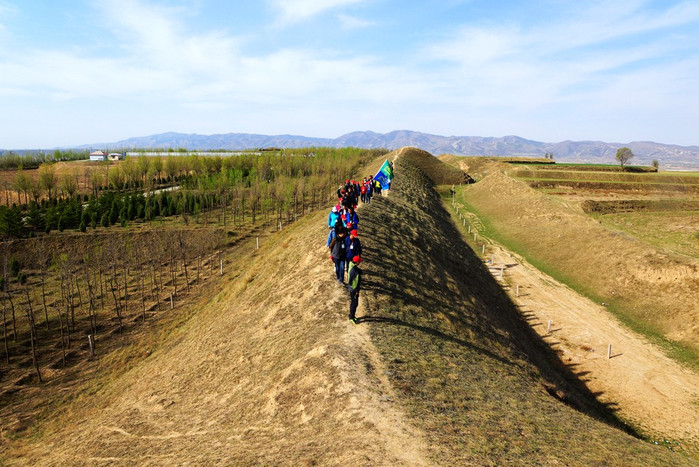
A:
326 176 381 324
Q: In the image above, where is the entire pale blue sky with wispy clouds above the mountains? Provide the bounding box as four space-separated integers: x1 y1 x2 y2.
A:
0 0 699 148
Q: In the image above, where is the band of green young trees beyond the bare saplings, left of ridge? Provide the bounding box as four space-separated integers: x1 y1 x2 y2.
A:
0 148 385 238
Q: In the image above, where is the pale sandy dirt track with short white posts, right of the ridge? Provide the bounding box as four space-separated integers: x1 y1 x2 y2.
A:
487 244 699 450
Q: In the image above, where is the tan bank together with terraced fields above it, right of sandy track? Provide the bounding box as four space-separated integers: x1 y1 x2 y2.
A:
450 158 699 368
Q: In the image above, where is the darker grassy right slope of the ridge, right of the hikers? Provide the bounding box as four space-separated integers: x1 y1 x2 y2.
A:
359 149 685 465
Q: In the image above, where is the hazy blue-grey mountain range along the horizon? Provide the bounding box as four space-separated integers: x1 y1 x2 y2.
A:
69 130 699 170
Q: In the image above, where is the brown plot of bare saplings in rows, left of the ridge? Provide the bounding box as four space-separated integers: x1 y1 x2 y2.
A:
0 229 226 380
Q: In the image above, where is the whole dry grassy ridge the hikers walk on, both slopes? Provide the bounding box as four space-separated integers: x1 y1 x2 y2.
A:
0 149 691 465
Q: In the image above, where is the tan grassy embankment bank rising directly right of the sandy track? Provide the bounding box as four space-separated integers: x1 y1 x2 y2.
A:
448 163 699 368
